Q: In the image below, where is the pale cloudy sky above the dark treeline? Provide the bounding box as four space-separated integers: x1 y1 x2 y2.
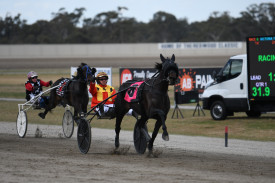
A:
0 0 275 24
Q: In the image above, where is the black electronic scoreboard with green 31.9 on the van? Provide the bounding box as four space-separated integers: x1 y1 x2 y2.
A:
246 36 275 101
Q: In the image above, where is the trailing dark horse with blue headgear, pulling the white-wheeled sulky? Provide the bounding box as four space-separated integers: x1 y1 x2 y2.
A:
38 63 96 120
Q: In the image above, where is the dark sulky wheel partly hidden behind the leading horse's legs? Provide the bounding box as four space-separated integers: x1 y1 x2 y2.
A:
134 123 148 154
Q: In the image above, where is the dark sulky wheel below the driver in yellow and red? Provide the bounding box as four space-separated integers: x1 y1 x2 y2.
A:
77 119 92 154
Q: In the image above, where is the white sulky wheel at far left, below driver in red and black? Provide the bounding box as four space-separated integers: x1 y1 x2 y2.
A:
16 111 28 138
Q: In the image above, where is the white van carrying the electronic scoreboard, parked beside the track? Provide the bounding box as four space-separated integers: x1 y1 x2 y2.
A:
202 36 275 120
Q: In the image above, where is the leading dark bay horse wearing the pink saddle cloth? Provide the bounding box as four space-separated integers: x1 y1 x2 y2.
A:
115 54 178 152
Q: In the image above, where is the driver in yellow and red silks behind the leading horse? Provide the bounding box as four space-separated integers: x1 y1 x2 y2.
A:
89 72 116 115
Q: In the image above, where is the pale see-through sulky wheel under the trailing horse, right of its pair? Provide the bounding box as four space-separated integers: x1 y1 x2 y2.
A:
62 110 74 138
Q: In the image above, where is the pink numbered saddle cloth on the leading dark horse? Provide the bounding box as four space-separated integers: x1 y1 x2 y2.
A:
124 81 144 102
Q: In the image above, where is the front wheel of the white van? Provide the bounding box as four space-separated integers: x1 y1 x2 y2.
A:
210 101 227 120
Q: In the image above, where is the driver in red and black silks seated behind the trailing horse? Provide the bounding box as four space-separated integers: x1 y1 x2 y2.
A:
25 71 53 107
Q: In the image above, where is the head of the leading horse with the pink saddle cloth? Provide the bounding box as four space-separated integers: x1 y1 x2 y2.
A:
157 54 179 85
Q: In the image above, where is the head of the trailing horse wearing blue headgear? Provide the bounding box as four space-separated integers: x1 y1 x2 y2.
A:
76 63 96 83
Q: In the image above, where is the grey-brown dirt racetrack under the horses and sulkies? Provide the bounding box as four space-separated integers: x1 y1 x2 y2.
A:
0 122 275 183
